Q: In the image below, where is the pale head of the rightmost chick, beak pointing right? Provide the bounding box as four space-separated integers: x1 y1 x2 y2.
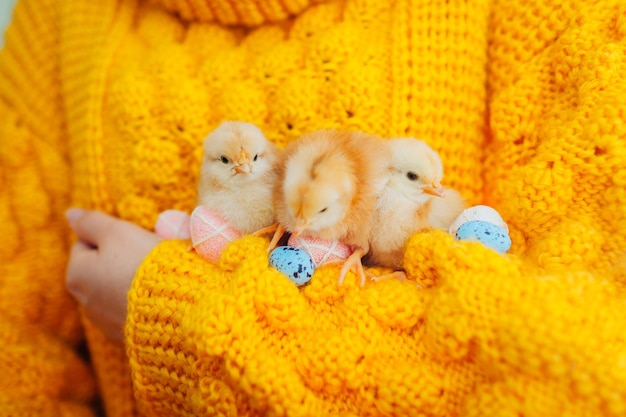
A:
388 138 444 200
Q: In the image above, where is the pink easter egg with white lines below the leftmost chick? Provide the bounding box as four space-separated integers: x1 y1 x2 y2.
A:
189 205 241 262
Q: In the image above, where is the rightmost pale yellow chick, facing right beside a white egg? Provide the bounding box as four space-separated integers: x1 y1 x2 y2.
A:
366 138 466 269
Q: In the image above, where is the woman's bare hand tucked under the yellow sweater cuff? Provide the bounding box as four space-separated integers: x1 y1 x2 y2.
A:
66 208 160 340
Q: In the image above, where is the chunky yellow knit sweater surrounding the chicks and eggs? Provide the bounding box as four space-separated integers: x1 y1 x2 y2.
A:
0 0 626 417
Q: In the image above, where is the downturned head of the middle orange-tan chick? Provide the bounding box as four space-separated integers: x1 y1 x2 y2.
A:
284 150 356 236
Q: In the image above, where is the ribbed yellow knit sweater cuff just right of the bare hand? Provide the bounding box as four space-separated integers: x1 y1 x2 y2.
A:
125 240 211 414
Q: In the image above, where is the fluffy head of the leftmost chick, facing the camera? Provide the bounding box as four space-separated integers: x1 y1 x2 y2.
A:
201 121 276 185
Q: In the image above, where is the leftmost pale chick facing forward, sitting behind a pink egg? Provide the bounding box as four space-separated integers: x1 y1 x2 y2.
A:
198 121 278 234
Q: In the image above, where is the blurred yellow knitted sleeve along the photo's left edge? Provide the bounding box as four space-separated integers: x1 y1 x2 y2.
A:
0 0 95 416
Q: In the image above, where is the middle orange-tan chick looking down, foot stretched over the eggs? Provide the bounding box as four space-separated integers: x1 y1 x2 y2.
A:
273 130 388 284
